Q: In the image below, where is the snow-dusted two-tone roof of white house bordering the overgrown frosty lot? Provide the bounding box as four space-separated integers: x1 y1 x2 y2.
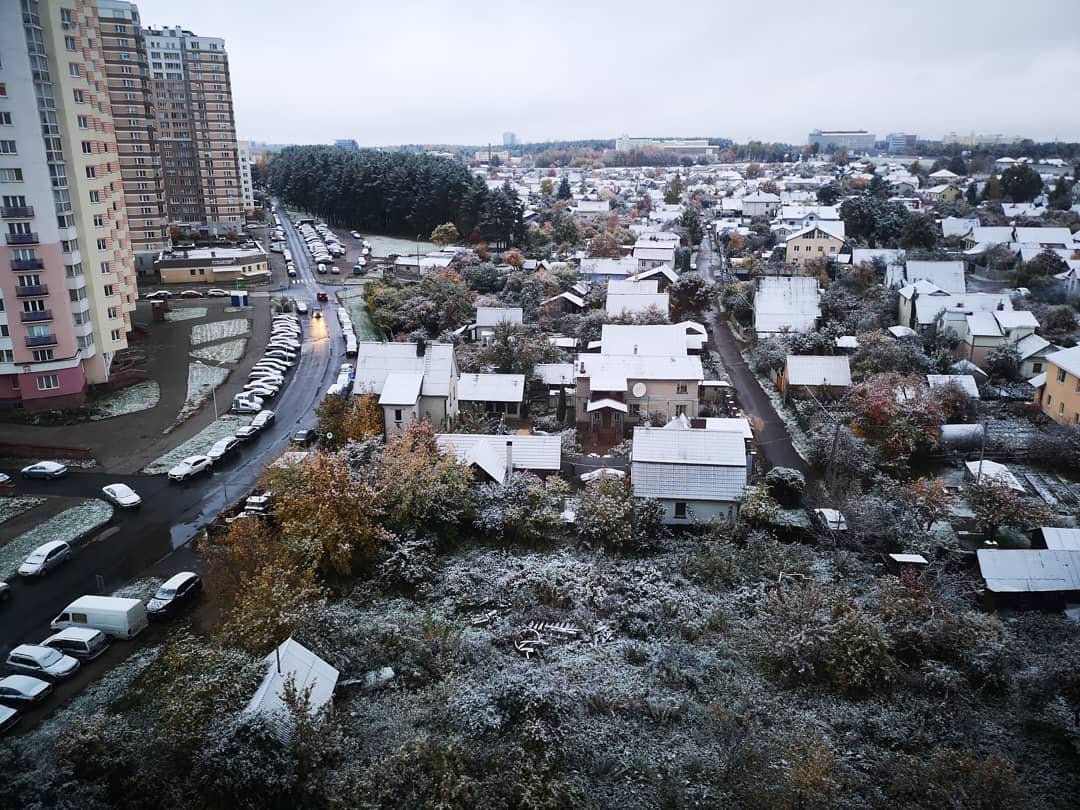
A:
631 428 746 501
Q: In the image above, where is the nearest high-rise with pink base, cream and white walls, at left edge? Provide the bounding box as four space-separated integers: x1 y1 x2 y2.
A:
0 0 136 409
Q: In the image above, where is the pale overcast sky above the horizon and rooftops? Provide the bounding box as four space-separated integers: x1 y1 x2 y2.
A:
132 0 1080 146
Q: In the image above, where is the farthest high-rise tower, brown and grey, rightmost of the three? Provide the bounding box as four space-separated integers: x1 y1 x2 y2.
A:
143 26 244 233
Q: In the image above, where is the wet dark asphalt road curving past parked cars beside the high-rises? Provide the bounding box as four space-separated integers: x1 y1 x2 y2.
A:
0 198 345 665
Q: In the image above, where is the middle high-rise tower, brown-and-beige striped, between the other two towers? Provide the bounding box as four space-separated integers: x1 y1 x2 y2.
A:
95 0 168 269
